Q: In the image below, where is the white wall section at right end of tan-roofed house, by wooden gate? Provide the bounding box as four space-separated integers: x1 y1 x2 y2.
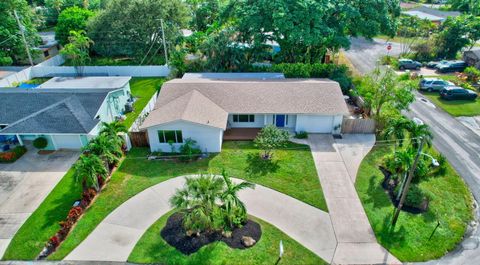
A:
295 114 343 133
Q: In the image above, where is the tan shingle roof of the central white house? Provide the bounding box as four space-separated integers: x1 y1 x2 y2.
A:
142 79 348 129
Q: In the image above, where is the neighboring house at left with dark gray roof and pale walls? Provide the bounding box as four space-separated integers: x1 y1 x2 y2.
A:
0 77 130 150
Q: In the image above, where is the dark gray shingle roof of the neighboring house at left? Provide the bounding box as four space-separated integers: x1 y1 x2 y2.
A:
0 89 108 134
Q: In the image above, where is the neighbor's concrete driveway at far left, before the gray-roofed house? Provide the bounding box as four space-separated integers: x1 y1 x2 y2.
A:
0 148 80 257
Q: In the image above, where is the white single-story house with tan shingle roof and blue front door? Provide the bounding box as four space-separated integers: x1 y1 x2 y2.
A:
140 78 348 152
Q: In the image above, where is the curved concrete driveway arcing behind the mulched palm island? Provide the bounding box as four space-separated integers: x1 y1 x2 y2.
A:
65 177 337 262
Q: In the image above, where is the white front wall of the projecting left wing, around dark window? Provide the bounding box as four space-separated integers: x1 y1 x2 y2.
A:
148 121 223 153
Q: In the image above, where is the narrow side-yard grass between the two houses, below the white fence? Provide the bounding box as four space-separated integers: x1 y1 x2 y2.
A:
123 77 165 128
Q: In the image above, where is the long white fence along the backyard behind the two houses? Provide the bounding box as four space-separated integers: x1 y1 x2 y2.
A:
32 65 170 77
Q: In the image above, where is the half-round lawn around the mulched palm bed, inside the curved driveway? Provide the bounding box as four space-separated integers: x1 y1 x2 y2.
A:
128 212 327 265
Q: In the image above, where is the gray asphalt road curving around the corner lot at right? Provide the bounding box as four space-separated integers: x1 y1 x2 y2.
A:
345 38 480 265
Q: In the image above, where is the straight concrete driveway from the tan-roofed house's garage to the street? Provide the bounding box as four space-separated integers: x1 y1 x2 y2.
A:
308 134 401 264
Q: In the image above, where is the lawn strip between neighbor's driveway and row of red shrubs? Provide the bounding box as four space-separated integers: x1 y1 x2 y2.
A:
3 169 82 260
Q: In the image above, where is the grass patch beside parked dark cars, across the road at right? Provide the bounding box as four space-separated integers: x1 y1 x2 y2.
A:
422 92 480 117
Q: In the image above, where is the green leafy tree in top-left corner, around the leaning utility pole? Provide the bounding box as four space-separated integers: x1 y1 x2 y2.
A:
0 0 40 65
